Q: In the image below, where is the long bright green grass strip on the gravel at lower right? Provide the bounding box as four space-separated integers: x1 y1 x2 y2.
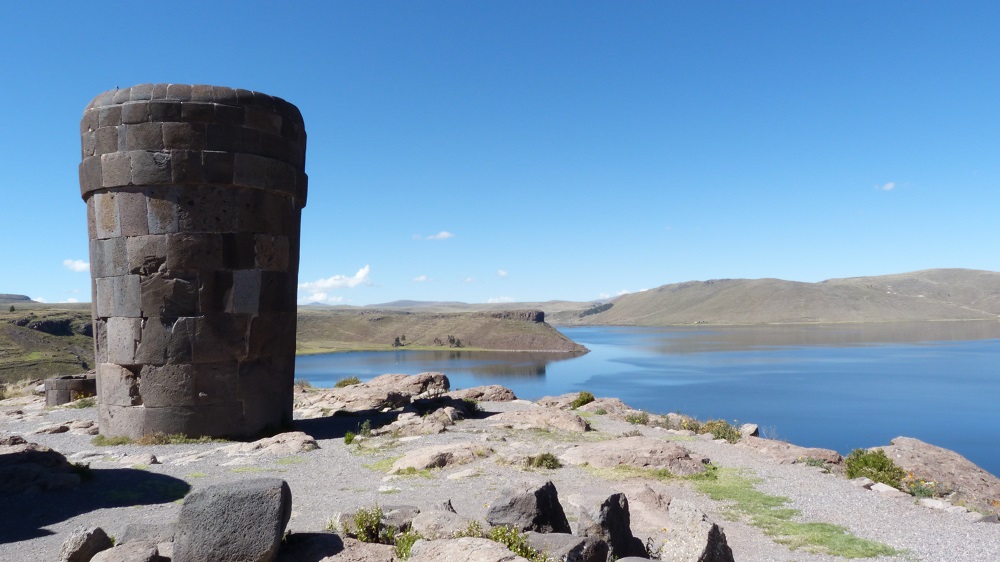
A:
695 469 902 558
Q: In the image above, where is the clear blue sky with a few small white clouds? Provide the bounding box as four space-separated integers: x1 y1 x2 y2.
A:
0 0 1000 305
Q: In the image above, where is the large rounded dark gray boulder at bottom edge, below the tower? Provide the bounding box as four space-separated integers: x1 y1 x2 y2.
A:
173 478 292 562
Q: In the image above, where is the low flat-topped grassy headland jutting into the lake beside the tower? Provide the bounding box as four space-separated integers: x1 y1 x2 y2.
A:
296 307 586 353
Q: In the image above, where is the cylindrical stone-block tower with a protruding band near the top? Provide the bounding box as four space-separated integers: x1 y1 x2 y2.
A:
80 84 306 437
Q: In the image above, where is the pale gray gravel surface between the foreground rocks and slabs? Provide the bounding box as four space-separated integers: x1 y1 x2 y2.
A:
0 399 1000 562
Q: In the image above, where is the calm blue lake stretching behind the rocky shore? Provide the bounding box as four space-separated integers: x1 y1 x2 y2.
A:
296 322 1000 474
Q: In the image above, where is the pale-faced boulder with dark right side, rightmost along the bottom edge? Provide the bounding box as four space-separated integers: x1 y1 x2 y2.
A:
660 499 733 562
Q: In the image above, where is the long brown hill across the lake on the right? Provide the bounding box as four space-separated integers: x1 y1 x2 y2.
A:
549 269 1000 326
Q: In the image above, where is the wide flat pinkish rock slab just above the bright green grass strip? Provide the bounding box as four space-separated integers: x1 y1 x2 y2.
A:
559 435 707 476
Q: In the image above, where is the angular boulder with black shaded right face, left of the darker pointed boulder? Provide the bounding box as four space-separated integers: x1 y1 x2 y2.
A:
486 480 570 533
